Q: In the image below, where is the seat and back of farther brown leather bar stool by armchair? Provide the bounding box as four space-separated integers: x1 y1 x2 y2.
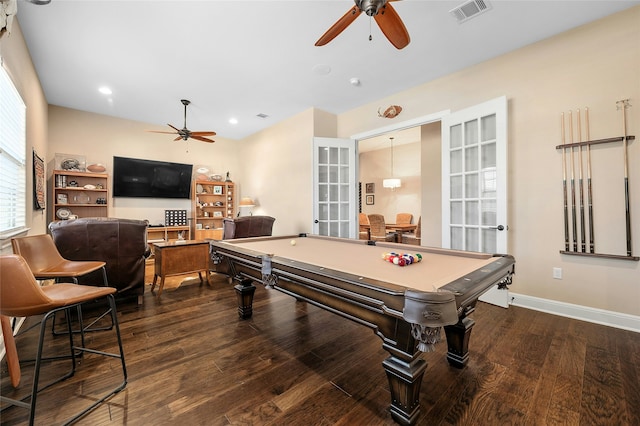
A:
11 234 113 334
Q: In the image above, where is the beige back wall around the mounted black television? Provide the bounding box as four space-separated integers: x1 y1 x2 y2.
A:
47 105 242 224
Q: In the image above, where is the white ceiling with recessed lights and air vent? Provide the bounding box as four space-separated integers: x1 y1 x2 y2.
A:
17 0 640 143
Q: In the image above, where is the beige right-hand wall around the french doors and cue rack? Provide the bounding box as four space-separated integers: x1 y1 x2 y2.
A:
338 7 640 315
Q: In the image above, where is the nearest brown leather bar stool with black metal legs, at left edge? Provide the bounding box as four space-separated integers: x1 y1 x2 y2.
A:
0 254 127 425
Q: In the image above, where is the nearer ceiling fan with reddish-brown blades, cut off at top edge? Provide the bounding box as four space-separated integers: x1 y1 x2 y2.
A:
316 0 411 49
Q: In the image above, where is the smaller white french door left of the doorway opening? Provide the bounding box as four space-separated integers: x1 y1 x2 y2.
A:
312 138 358 238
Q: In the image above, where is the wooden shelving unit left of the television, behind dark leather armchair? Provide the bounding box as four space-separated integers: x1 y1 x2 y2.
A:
51 170 109 221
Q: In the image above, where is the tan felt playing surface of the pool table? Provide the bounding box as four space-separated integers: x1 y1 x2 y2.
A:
227 237 497 291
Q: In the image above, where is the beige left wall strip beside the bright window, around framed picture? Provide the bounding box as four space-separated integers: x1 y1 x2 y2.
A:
0 19 49 240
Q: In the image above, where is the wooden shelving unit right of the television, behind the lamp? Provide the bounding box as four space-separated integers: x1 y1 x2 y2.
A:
191 180 236 240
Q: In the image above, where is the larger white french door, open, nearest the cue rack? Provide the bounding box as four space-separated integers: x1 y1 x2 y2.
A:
442 97 507 253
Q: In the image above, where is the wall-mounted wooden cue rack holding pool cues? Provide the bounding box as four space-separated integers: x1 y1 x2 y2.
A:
556 99 640 261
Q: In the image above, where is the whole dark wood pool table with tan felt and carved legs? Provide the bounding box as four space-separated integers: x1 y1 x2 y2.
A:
210 234 515 424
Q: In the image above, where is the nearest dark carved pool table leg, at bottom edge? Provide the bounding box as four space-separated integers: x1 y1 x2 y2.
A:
382 355 427 425
